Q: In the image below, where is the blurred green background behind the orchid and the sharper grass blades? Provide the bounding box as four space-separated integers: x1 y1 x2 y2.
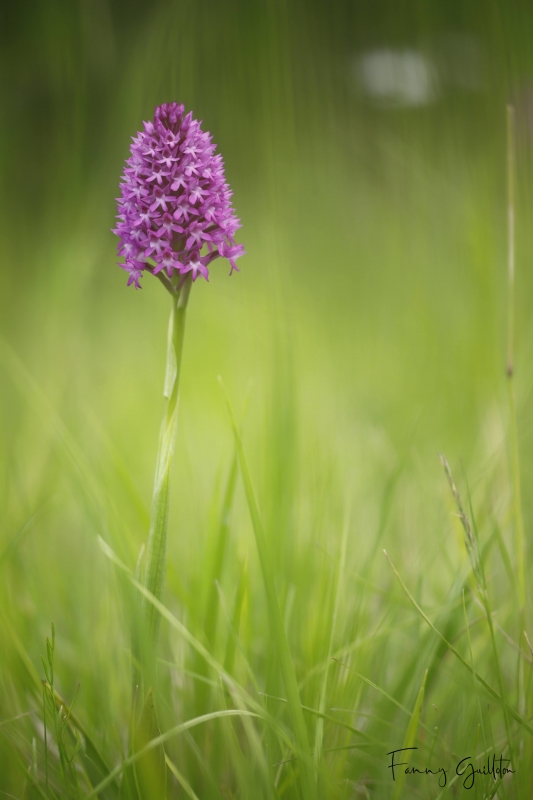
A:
0 0 533 797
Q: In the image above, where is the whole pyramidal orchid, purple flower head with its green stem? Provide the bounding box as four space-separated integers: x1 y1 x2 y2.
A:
113 103 244 694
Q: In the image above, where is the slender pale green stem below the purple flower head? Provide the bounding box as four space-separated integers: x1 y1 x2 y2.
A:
142 276 191 666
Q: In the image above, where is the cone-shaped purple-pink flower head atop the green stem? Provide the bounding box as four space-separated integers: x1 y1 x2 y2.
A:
113 103 244 289
